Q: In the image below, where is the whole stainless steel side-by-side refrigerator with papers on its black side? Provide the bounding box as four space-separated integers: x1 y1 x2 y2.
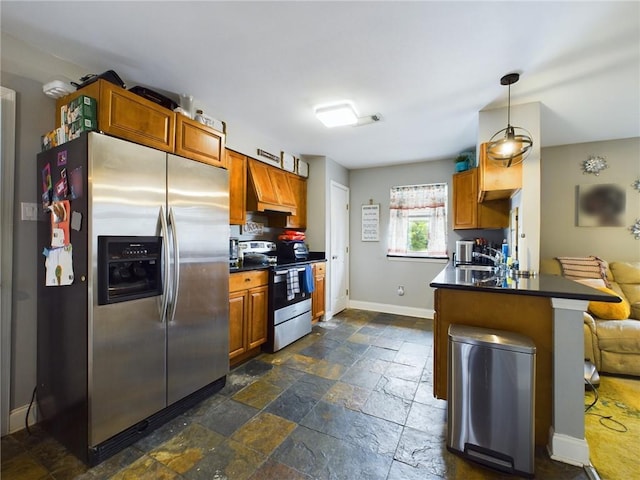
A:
37 132 229 464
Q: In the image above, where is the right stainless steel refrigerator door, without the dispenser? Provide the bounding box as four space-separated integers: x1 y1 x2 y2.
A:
167 155 229 405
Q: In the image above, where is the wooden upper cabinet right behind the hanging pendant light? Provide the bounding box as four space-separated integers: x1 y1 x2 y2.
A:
478 143 522 202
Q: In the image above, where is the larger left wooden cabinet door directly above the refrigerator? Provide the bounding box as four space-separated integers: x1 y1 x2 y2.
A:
98 80 176 153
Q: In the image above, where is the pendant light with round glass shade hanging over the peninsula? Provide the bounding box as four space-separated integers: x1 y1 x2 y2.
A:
487 73 533 167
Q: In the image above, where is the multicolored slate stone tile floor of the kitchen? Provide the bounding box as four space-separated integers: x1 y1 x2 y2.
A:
1 310 588 480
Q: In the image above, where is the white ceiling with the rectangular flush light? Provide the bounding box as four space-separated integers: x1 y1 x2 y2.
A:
0 0 640 169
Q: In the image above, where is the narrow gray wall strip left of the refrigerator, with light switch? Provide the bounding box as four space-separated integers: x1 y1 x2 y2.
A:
2 72 55 416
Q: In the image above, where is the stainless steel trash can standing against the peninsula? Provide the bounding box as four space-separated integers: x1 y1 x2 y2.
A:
447 325 536 477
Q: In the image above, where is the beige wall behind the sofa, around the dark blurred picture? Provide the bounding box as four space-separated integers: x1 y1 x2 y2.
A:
540 138 640 261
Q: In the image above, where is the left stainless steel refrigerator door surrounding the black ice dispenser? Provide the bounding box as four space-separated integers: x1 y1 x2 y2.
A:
88 134 166 445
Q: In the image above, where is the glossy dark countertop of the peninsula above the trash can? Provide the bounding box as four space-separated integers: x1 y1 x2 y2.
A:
429 264 621 303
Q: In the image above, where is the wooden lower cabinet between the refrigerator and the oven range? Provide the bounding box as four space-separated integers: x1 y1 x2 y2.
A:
229 270 269 365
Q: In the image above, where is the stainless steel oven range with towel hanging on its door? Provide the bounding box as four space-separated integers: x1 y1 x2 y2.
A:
265 263 311 352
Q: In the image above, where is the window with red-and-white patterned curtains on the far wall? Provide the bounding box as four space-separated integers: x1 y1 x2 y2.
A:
387 183 447 258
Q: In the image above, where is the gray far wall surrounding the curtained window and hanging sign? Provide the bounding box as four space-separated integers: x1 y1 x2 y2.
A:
349 159 504 312
